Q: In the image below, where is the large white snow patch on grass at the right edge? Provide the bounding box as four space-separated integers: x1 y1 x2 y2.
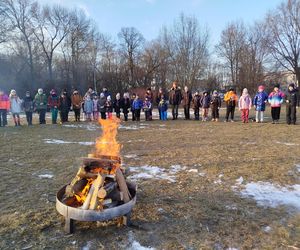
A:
241 182 300 210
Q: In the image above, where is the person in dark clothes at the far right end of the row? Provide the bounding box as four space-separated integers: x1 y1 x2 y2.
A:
286 83 300 125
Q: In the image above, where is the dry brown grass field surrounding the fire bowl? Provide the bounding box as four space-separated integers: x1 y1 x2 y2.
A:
0 107 300 250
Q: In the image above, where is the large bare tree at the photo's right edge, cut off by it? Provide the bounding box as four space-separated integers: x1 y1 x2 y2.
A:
265 0 300 83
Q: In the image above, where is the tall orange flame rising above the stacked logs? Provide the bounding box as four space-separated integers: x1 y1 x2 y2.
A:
94 116 121 157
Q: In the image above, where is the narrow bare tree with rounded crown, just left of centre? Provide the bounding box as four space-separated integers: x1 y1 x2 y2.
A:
118 27 145 87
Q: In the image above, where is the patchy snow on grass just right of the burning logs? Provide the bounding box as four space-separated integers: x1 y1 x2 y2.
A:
128 165 186 182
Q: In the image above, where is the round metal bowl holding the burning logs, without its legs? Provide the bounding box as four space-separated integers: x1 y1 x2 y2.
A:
56 182 137 221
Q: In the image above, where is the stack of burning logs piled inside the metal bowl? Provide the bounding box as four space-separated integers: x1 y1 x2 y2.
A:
62 154 132 211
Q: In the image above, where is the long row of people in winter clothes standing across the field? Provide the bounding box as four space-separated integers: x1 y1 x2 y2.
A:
0 82 300 126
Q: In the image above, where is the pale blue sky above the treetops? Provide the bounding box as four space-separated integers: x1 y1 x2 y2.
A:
38 0 282 45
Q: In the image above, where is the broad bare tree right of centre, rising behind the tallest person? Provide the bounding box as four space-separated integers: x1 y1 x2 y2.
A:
162 14 209 88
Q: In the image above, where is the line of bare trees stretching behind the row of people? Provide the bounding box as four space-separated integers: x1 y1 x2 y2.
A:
0 0 300 95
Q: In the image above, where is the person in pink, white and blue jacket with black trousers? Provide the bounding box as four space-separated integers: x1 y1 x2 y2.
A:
268 84 284 124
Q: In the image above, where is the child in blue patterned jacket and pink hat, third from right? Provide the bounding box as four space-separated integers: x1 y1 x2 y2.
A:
253 85 268 122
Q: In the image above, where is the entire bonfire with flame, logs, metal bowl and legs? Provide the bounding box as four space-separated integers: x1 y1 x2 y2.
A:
56 117 136 233
